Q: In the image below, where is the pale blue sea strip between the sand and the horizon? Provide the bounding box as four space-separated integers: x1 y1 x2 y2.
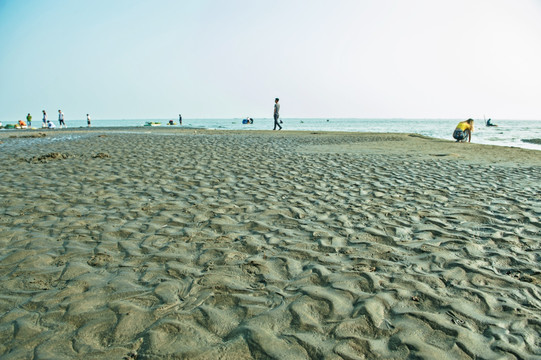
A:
7 118 541 150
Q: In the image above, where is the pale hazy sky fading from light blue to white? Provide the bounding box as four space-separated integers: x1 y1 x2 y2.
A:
0 0 541 122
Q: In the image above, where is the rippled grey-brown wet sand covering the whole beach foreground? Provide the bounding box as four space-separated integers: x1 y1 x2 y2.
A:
0 128 541 359
